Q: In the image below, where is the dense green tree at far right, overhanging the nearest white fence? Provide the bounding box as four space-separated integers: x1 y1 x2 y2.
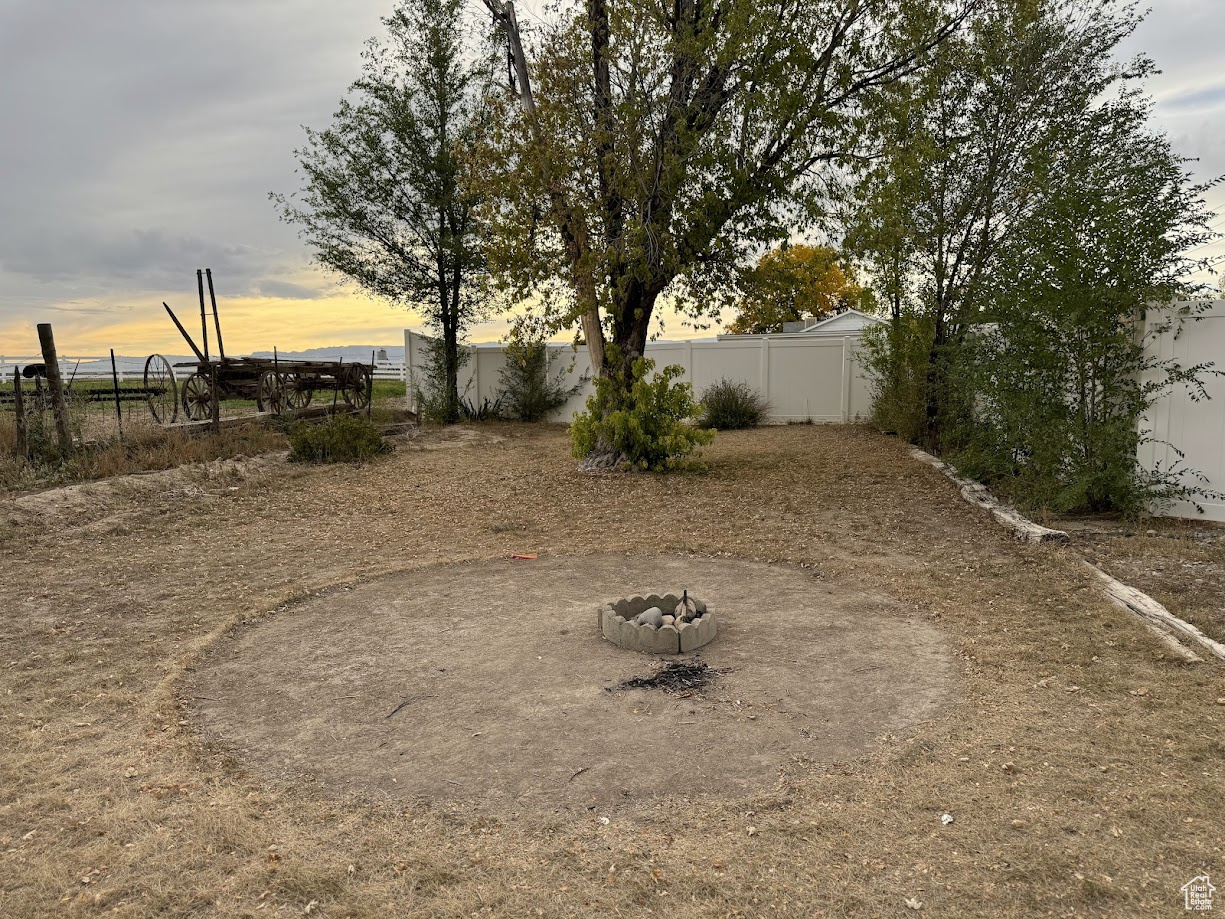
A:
959 92 1218 513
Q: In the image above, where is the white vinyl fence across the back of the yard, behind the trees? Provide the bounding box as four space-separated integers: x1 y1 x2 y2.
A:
404 330 871 424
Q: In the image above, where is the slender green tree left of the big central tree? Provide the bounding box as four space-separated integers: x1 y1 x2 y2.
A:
272 0 491 422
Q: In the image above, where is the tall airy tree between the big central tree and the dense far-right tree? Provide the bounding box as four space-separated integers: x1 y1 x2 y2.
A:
848 0 1150 450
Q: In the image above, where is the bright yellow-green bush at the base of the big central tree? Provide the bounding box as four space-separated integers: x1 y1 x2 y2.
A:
570 358 714 472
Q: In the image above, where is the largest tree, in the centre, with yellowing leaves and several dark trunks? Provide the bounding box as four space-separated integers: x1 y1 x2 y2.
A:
477 0 959 463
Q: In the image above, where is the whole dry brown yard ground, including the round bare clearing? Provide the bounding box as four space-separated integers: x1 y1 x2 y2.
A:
0 425 1225 918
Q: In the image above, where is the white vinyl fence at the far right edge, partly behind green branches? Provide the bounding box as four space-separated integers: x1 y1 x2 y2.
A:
1140 300 1225 521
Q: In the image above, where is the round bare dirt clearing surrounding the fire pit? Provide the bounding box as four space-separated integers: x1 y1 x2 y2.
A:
187 555 953 811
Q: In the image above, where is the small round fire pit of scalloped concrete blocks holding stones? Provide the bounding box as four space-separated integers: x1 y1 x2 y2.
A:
599 591 719 654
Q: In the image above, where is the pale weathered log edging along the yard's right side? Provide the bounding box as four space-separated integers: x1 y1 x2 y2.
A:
910 447 1225 663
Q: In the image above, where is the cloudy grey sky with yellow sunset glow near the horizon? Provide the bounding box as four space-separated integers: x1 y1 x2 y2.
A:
0 0 1225 355
